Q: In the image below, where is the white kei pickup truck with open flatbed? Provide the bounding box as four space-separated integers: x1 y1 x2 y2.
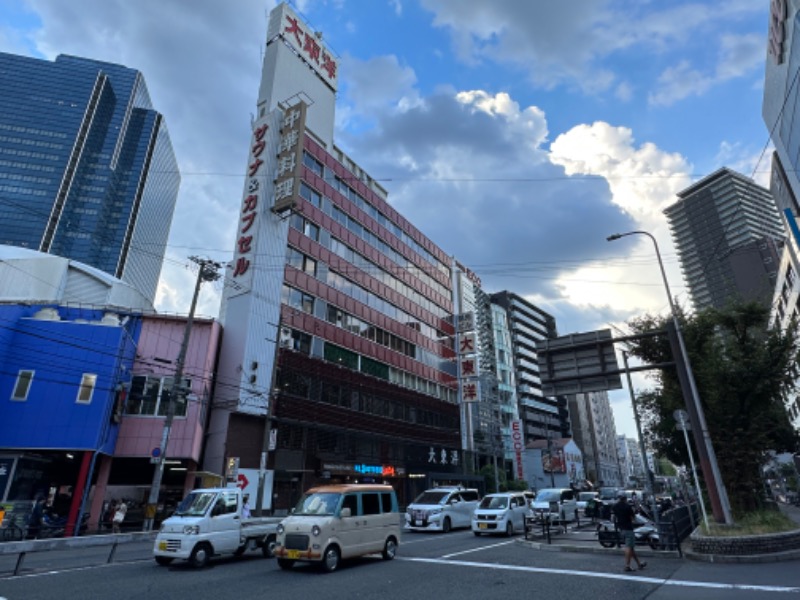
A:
153 488 281 568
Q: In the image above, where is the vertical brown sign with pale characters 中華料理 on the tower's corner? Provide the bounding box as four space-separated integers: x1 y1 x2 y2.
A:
272 102 306 213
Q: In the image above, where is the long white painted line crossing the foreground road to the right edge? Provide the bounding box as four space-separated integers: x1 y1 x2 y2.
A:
397 557 800 594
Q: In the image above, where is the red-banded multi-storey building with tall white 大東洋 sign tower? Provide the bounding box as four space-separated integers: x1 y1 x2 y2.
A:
204 4 482 509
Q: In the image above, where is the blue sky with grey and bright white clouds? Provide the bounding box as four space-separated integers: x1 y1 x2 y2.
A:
0 0 770 437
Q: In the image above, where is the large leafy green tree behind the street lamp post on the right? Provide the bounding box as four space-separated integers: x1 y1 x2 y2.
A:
628 303 800 514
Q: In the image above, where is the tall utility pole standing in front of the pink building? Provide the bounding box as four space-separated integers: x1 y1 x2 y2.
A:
144 256 222 531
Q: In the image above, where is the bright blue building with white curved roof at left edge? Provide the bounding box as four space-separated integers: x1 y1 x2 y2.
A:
0 246 152 522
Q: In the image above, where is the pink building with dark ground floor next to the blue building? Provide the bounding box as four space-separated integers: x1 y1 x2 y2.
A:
91 315 221 528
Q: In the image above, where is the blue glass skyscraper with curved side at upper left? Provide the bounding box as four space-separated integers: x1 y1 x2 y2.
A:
0 53 180 300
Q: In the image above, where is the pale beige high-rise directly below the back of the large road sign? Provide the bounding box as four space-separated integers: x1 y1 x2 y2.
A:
569 392 624 486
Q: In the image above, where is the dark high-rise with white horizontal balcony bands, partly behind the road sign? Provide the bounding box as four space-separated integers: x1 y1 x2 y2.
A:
491 291 572 444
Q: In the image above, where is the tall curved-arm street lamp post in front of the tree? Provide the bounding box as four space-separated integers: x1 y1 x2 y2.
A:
606 231 733 524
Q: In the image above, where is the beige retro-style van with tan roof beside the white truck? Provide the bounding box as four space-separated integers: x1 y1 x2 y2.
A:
275 484 400 572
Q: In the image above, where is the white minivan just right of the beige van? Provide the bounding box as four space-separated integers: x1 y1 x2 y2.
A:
405 487 480 533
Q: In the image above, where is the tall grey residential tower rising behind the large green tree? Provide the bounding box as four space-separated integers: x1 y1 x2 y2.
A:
664 168 784 310
